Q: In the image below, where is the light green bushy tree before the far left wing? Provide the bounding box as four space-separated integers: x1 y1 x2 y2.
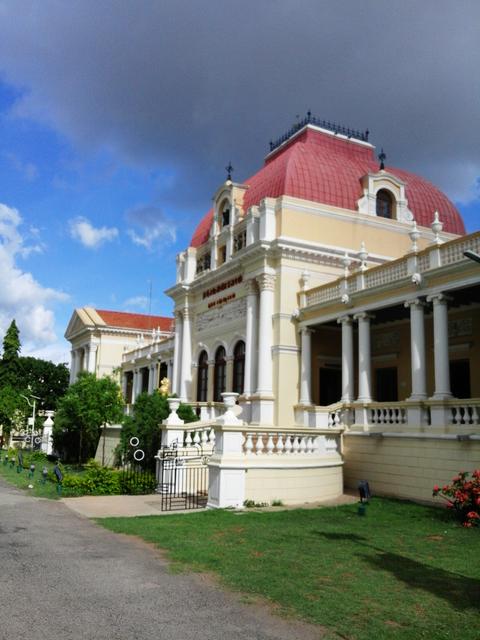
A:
53 372 123 463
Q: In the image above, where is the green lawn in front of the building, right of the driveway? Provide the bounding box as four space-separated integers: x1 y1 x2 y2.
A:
98 498 480 640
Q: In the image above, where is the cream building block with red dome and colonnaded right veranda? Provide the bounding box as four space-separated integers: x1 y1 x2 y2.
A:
65 114 480 506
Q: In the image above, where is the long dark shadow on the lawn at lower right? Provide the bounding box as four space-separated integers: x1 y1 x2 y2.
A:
361 553 480 610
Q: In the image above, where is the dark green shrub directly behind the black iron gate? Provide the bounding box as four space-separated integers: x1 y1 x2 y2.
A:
121 391 198 467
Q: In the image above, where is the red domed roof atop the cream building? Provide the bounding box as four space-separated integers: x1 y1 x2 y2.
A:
191 127 465 247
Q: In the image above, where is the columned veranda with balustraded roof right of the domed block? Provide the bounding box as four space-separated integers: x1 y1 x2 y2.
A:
297 233 480 433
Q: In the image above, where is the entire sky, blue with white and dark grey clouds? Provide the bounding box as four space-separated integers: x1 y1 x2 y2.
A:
0 0 480 361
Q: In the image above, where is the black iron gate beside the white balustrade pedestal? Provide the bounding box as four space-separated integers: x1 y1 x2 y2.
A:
157 447 209 511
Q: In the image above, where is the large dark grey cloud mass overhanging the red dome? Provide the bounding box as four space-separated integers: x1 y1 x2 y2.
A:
0 0 480 209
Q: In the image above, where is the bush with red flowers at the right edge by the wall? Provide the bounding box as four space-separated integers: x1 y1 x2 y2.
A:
433 469 480 527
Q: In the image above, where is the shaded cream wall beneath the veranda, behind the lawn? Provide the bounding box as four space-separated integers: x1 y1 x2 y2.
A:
344 434 480 504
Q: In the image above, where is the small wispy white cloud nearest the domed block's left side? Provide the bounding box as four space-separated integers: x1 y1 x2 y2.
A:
126 205 177 251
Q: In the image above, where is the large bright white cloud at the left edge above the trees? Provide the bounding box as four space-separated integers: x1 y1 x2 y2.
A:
0 204 68 353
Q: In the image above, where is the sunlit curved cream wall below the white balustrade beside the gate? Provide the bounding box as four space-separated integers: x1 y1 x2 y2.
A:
245 463 343 504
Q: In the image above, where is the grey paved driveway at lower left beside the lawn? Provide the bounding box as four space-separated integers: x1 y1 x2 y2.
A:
0 480 322 640
